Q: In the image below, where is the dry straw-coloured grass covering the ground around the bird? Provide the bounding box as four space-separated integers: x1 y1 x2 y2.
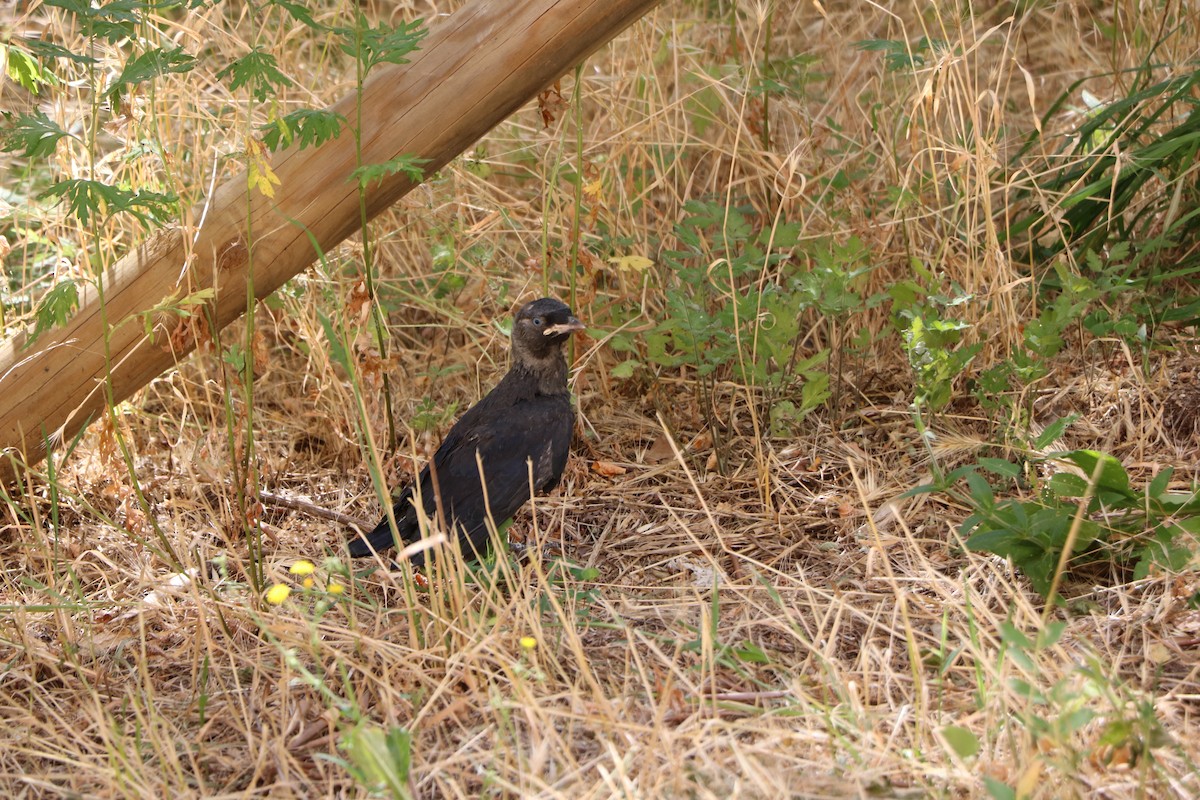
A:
0 1 1200 799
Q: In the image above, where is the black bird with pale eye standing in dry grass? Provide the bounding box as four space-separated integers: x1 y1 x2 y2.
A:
350 297 583 566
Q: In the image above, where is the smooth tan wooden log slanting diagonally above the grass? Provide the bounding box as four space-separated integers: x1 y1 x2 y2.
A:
0 0 658 482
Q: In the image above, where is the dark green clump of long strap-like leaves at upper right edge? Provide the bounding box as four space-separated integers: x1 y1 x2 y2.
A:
1003 62 1200 348
